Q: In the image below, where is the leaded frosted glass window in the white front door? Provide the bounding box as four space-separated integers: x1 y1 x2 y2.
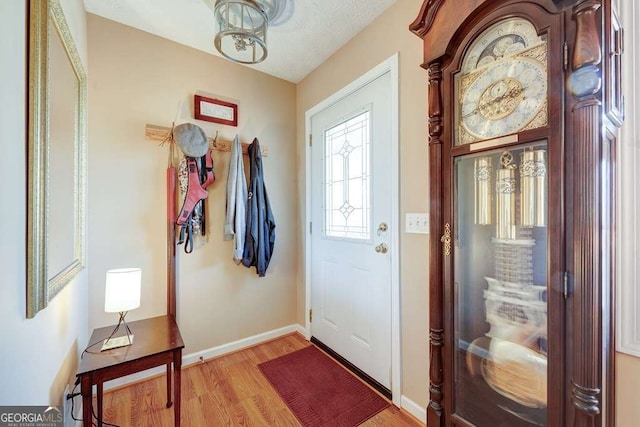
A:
324 111 371 240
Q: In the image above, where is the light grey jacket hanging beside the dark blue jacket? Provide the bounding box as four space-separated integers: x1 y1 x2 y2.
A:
224 135 247 264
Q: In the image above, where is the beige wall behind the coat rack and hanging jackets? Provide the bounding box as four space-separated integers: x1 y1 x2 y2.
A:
88 15 299 354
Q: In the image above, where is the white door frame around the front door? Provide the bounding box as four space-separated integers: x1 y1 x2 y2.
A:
304 53 402 407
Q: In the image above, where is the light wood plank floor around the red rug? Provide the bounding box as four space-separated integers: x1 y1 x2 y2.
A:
100 334 422 427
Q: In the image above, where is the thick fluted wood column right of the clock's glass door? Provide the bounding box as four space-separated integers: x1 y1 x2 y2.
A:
569 0 603 426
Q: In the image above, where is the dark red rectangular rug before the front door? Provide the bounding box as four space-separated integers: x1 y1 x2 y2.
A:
258 346 389 427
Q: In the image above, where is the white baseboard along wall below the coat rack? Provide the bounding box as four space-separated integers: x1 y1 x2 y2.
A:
104 324 305 390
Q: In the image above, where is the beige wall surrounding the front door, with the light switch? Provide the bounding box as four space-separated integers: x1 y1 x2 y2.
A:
297 0 428 407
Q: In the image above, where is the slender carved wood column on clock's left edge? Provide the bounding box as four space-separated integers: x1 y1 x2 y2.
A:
427 62 444 427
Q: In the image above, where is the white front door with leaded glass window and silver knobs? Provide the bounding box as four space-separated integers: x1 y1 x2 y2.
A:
311 72 397 389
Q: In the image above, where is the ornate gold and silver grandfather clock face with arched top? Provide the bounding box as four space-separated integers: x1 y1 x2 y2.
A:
454 18 548 145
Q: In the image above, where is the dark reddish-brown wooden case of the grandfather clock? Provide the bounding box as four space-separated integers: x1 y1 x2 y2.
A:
409 0 623 427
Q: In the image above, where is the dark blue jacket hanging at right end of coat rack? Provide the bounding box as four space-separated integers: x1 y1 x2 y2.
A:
242 138 276 277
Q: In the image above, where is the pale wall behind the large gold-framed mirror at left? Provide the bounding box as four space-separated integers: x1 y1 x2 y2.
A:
0 0 88 405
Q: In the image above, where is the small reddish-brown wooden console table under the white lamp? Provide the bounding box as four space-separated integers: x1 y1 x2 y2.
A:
77 316 184 427
